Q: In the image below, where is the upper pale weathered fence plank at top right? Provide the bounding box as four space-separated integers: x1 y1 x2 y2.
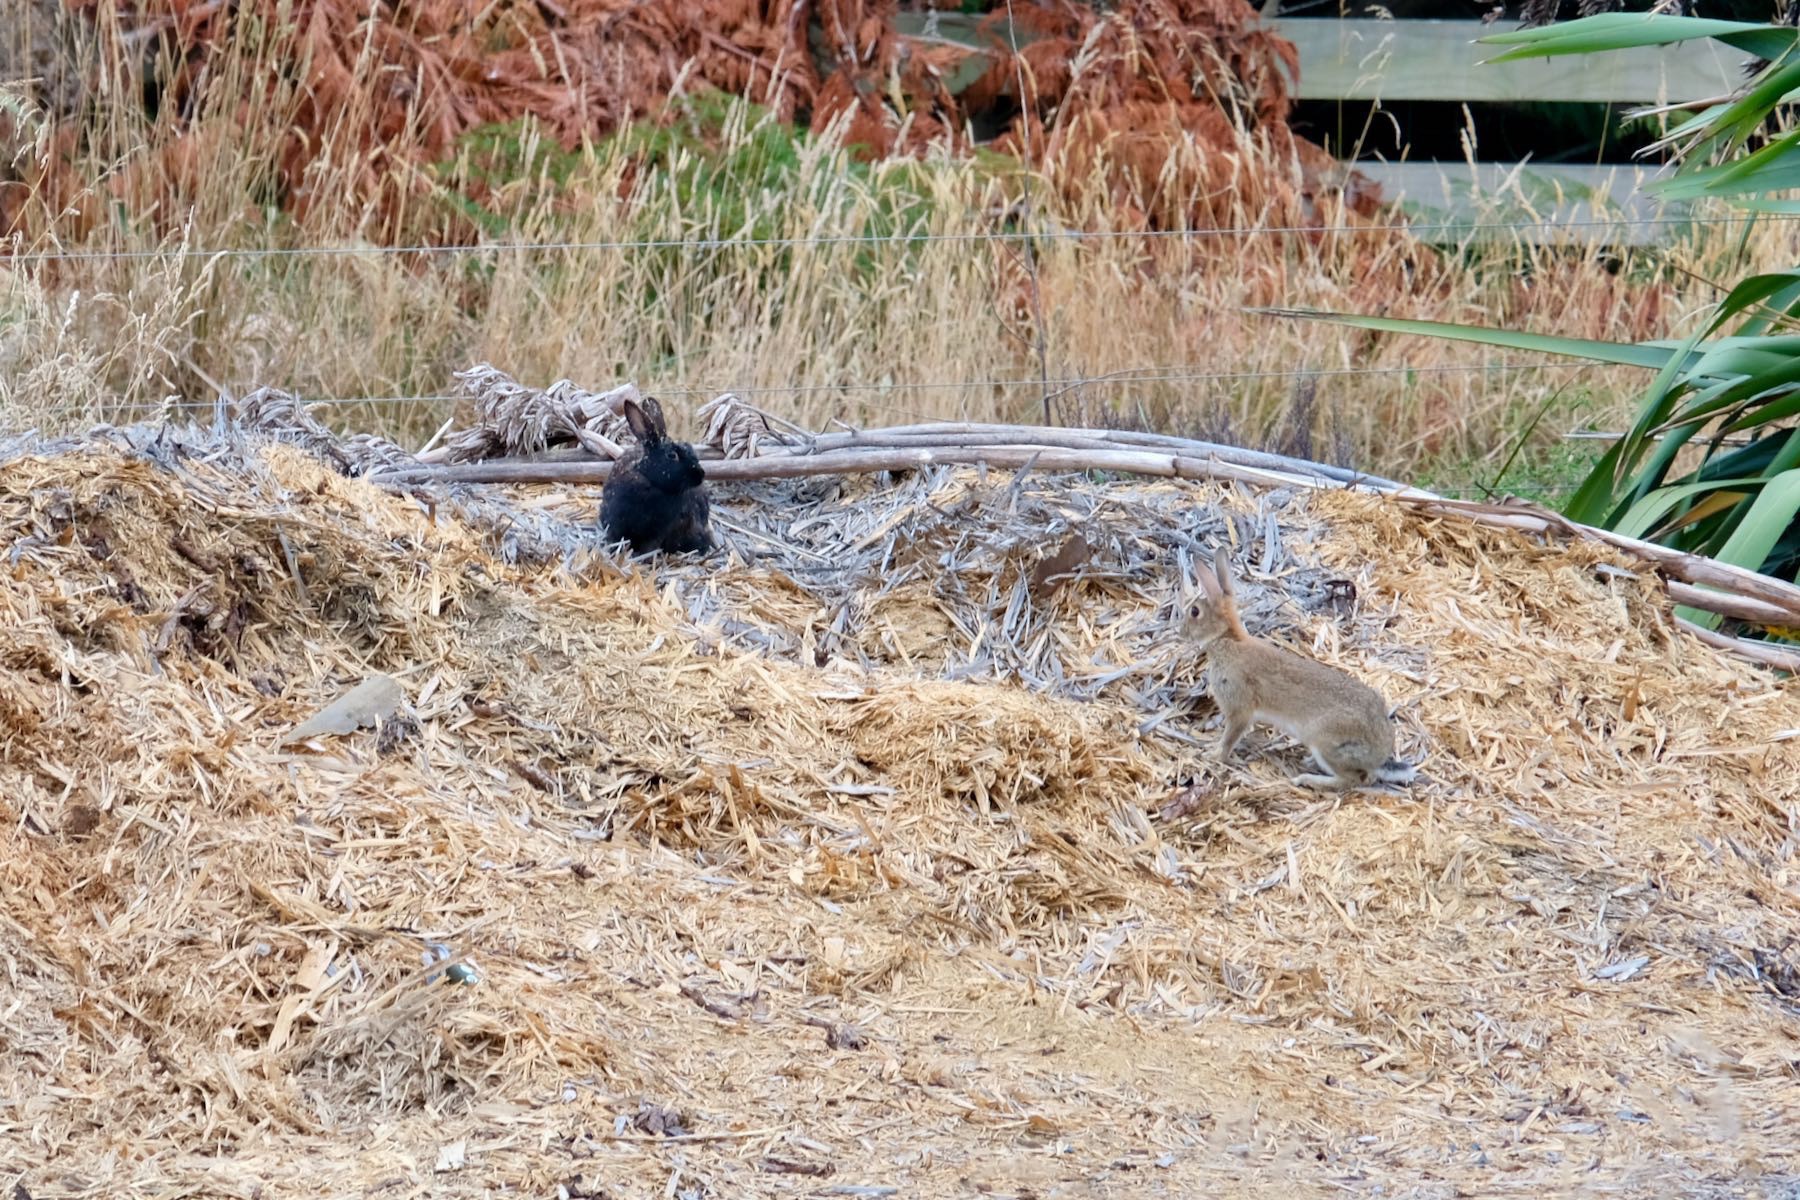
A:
1269 18 1744 104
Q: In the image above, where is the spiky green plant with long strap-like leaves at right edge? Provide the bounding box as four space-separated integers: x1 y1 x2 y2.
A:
1269 13 1800 637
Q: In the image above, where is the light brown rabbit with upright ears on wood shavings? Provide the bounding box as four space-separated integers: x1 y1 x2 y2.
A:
1183 565 1415 792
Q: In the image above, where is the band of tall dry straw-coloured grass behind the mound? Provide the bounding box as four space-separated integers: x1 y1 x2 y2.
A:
0 4 1793 486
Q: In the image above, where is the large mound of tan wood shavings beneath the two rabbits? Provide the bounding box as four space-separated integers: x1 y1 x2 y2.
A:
0 432 1800 1198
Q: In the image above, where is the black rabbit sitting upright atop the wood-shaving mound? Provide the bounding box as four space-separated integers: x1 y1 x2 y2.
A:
599 398 713 554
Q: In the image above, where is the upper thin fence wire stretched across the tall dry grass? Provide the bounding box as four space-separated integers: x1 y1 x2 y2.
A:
0 212 1800 264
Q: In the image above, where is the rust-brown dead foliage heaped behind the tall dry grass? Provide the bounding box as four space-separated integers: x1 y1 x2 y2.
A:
21 0 1375 244
